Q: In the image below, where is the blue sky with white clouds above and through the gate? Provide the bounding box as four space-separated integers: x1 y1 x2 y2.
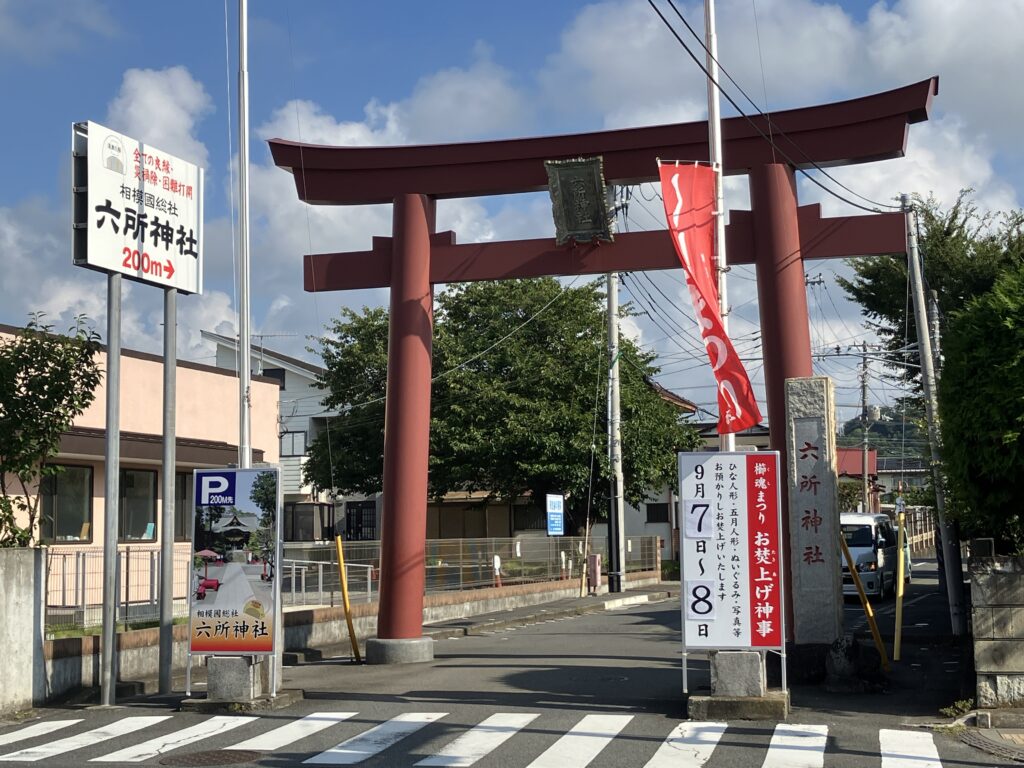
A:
0 0 1024 428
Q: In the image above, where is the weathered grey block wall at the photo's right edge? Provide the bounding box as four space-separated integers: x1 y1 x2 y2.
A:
970 557 1024 708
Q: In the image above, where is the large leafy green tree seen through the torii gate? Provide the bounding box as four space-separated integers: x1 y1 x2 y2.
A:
306 279 698 536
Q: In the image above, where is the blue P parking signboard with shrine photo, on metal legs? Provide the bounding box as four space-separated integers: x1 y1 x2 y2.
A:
185 467 282 697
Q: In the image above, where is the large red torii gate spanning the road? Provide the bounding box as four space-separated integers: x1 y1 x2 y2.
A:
269 78 938 660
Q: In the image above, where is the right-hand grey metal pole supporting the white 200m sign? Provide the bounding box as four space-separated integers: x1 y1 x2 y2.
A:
160 288 178 694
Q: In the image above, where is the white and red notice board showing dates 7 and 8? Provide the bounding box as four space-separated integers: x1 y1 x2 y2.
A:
679 452 785 648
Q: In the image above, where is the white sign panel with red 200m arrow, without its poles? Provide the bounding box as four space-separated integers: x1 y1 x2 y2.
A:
72 121 203 293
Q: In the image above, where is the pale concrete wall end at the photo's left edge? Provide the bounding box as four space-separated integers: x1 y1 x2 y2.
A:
0 549 45 716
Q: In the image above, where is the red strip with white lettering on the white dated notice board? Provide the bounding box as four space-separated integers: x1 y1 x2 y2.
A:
746 454 782 648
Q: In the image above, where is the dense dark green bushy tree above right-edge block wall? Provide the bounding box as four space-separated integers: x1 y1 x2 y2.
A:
939 262 1024 553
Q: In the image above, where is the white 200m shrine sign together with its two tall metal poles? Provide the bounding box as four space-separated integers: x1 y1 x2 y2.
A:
72 121 203 705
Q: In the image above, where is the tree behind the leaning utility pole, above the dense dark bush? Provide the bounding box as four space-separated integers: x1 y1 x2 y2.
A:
839 189 1024 388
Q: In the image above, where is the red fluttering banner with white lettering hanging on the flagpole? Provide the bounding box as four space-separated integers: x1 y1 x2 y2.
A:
658 164 761 434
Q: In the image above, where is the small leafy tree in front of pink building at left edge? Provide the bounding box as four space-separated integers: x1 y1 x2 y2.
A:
0 314 102 547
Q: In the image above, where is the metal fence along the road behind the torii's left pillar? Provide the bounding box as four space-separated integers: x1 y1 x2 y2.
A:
281 537 657 606
